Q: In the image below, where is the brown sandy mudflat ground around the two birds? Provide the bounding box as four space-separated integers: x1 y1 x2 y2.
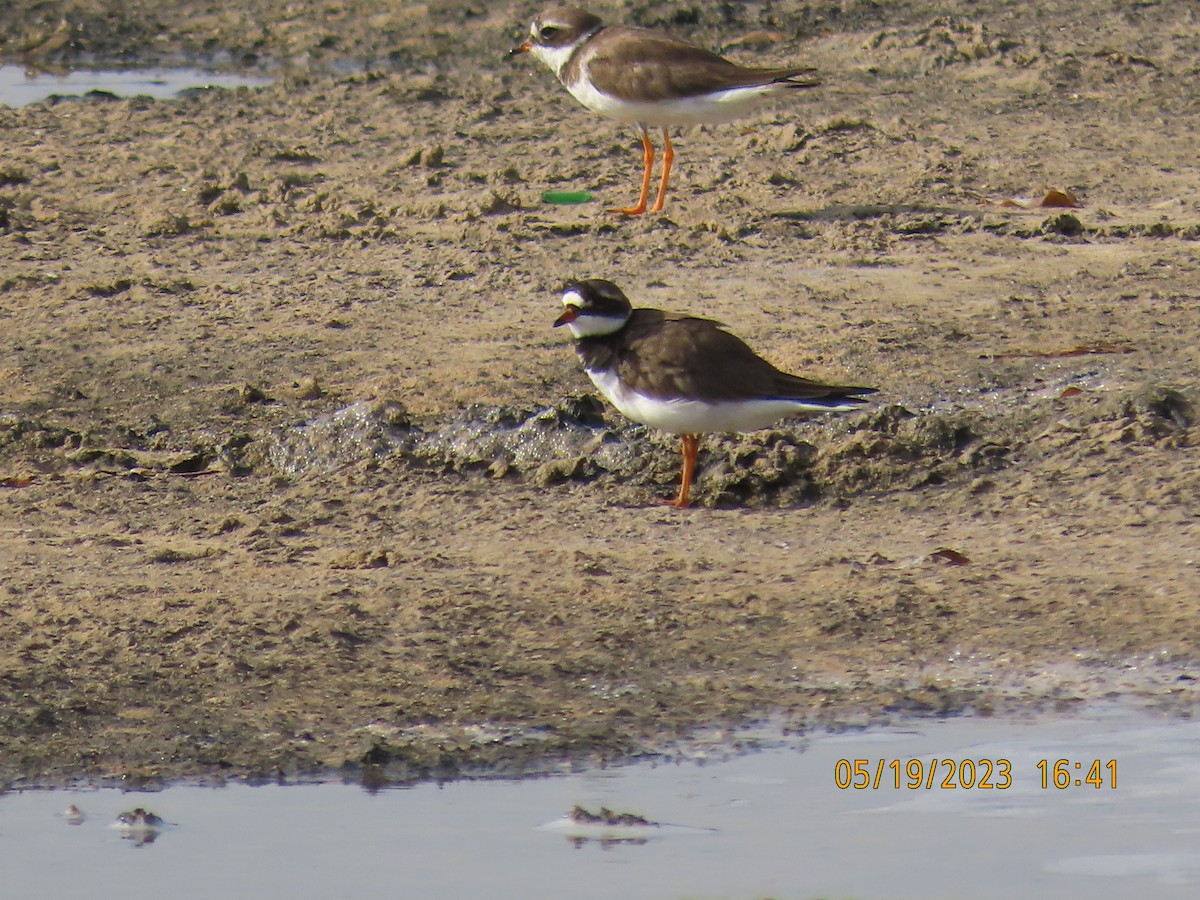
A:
0 0 1200 785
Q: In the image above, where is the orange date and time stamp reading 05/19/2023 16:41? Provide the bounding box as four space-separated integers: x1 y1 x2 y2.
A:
833 757 1117 791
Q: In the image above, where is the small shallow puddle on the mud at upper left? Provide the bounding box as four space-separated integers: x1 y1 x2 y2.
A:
0 66 271 107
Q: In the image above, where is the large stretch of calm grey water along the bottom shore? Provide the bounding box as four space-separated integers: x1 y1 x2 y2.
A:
0 710 1200 900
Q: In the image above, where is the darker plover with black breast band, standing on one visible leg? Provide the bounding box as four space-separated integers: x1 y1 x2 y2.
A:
554 278 876 509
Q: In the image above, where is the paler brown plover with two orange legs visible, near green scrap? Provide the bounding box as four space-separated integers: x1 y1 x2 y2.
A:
509 6 820 216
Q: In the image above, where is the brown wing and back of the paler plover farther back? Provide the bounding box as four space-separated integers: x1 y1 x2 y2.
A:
588 29 816 102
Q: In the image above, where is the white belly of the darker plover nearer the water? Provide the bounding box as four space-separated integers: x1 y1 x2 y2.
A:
588 371 825 434
